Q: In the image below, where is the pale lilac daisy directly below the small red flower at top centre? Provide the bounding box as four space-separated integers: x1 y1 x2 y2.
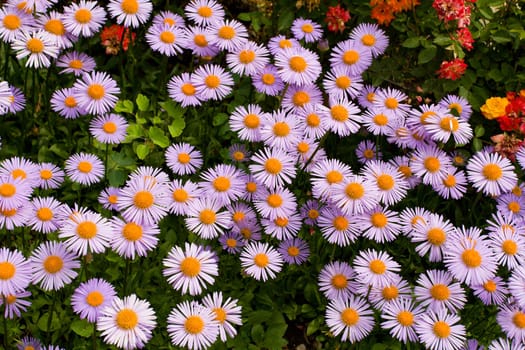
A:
330 40 375 74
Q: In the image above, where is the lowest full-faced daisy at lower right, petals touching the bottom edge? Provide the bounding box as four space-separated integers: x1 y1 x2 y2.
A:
415 310 466 350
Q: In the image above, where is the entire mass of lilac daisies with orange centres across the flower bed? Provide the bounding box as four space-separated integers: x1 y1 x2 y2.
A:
0 0 525 349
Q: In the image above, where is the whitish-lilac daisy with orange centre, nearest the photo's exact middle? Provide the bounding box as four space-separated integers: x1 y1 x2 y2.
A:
248 147 297 188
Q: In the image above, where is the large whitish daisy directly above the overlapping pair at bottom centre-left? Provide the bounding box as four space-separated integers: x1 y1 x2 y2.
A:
162 243 219 295
